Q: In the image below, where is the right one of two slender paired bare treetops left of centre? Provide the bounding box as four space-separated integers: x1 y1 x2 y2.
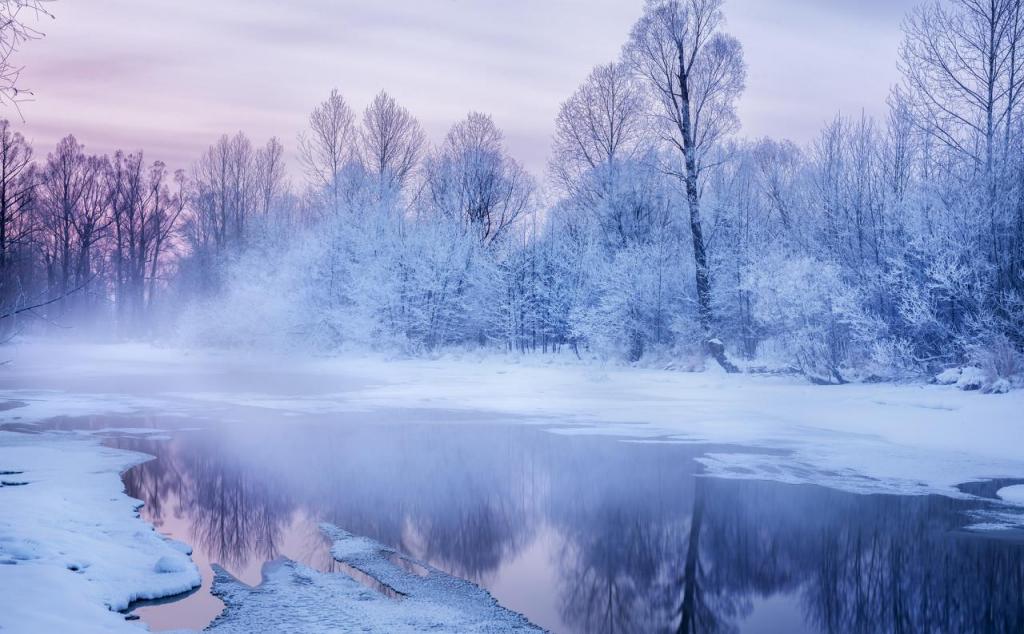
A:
360 91 426 195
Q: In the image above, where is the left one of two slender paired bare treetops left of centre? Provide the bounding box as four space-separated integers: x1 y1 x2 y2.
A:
299 89 356 213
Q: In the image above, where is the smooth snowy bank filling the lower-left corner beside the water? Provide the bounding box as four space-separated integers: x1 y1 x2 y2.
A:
0 431 200 633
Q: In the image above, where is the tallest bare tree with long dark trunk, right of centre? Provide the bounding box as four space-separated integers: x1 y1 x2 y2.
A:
624 0 745 348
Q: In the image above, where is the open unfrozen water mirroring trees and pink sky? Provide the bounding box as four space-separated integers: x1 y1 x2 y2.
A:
104 421 1024 634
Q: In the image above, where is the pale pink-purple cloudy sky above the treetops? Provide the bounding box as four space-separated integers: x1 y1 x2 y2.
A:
6 0 918 175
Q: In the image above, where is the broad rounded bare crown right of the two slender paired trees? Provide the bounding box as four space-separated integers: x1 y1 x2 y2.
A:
427 113 536 245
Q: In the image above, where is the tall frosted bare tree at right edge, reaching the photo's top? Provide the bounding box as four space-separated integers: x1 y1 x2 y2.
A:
900 0 1024 307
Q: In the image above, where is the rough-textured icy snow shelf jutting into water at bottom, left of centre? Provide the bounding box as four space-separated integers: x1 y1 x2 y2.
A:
207 524 543 634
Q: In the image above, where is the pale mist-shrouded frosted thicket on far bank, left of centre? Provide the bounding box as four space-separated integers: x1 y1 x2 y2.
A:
179 193 509 352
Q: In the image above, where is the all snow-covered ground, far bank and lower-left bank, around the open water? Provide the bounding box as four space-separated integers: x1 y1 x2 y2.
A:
0 343 1024 631
